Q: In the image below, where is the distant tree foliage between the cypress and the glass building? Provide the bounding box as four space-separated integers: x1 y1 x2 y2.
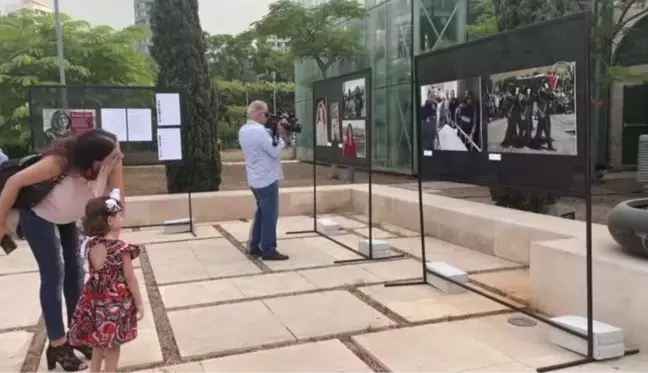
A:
207 32 294 82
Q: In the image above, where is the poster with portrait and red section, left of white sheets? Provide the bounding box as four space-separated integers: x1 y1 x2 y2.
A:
43 109 96 142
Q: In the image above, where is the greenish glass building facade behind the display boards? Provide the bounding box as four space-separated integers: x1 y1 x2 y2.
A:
295 0 476 174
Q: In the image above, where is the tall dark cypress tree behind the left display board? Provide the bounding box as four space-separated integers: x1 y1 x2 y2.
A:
151 0 221 193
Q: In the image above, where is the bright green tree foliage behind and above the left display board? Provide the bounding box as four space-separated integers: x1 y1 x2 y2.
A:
0 10 155 148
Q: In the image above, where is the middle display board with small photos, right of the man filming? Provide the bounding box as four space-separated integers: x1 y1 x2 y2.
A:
313 70 371 166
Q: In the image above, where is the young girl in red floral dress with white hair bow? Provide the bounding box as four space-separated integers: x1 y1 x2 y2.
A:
67 190 143 373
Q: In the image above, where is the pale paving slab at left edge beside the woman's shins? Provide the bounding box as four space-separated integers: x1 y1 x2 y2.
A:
0 273 41 330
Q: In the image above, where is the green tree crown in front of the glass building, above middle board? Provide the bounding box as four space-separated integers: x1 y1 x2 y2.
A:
254 0 365 77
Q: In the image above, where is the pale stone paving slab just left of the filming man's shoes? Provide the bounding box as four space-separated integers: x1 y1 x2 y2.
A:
147 238 261 284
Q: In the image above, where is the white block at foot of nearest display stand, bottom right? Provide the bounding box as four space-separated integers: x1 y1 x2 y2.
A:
549 316 625 360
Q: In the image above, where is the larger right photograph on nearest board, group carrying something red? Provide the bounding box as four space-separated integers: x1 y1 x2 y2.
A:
485 62 578 155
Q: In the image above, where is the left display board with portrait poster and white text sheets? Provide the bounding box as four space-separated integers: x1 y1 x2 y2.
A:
29 86 183 165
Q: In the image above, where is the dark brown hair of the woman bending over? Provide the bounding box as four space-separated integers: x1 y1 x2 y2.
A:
48 129 117 171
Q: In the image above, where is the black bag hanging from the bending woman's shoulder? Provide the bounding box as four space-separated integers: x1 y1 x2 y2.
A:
0 154 65 209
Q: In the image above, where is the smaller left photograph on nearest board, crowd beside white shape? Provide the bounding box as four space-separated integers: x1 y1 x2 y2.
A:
420 78 482 152
